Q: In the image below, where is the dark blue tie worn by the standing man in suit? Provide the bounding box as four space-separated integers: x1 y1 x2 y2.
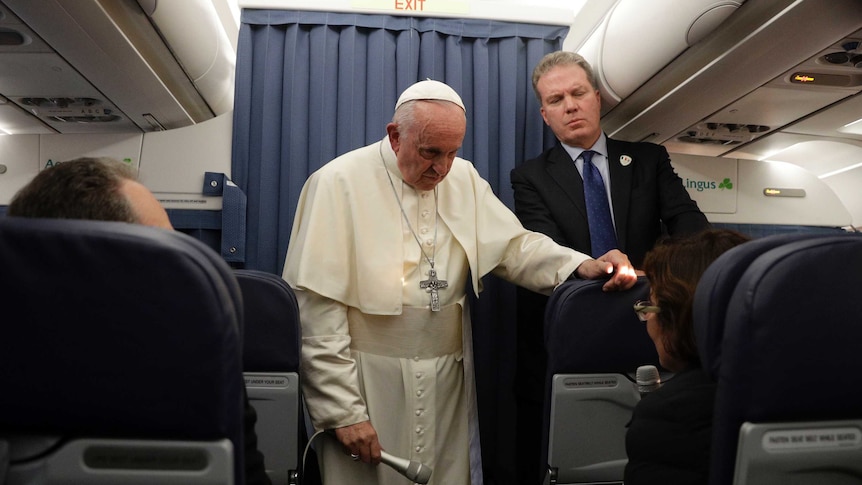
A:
581 150 617 258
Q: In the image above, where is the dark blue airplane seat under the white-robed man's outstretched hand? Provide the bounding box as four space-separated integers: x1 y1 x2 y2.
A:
537 277 659 484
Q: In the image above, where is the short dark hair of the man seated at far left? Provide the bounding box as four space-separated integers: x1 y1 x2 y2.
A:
7 158 137 223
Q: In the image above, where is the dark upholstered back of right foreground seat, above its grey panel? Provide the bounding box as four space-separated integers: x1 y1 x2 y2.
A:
695 234 862 484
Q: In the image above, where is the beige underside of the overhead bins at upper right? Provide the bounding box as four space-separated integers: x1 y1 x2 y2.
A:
602 0 862 148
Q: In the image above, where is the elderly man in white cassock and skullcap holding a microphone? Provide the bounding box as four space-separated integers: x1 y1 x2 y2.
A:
284 80 636 485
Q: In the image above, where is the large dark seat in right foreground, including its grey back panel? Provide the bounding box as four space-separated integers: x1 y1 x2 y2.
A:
694 234 862 485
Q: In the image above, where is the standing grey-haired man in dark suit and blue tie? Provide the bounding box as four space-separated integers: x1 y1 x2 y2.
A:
511 51 709 485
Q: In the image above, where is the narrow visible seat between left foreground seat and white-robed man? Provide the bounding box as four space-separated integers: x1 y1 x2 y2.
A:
234 270 304 485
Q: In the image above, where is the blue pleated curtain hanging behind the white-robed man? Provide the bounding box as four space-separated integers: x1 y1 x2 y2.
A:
232 9 568 485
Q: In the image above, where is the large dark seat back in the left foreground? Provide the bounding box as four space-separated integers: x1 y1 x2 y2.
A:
0 218 244 485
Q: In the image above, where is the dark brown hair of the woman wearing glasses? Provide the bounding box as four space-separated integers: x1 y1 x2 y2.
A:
644 229 750 365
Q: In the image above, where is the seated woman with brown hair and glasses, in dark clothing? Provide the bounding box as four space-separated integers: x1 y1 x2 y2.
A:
624 229 749 485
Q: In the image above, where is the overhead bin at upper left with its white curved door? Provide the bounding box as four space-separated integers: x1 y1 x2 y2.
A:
0 0 235 133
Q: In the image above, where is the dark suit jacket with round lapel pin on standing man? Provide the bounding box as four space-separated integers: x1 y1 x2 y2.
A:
511 138 709 267
